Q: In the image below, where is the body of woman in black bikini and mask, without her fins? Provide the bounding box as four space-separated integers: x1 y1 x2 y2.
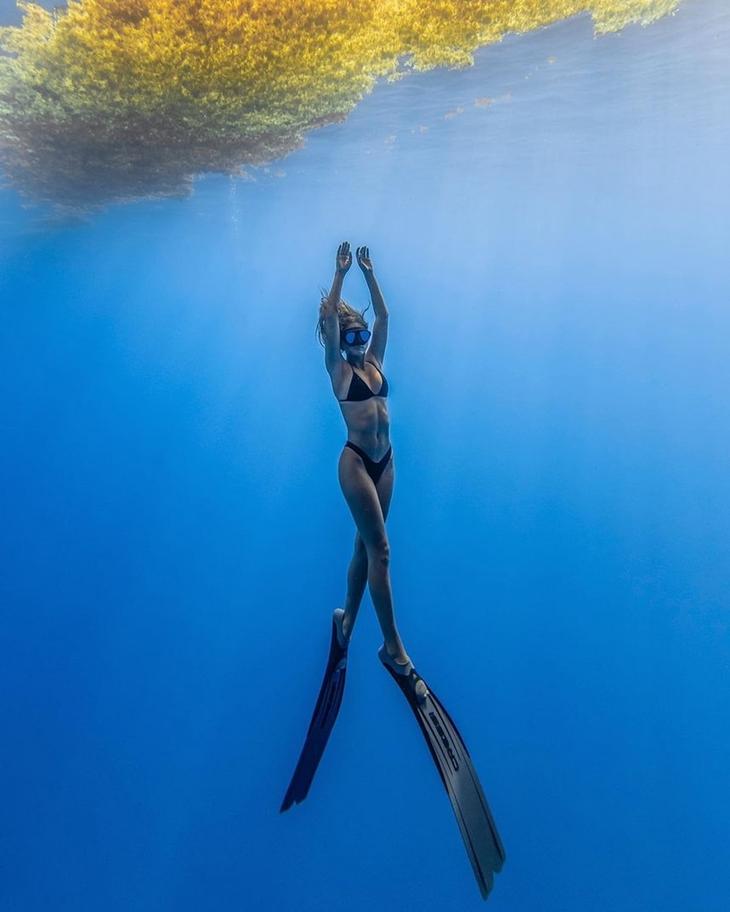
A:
317 241 409 667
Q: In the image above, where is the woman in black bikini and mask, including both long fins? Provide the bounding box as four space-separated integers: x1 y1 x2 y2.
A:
281 241 504 897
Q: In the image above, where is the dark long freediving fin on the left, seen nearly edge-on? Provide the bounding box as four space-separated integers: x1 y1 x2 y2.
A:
279 608 349 813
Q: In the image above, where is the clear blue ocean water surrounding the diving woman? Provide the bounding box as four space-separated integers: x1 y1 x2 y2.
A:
0 0 730 912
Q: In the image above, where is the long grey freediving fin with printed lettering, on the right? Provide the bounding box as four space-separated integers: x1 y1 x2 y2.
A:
378 647 505 899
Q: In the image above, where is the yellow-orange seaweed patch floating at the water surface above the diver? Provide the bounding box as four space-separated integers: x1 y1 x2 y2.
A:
0 0 679 207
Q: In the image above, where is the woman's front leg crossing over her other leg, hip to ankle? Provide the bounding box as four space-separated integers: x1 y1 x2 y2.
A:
339 447 405 658
